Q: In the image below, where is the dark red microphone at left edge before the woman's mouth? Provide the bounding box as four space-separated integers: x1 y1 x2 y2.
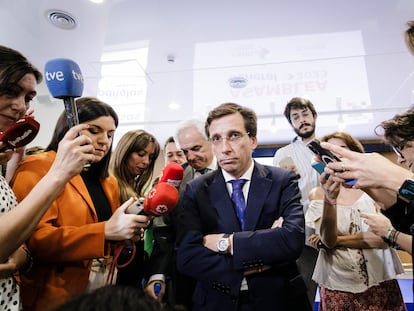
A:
0 116 40 152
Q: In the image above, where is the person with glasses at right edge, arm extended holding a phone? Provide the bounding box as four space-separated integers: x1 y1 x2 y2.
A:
322 108 414 253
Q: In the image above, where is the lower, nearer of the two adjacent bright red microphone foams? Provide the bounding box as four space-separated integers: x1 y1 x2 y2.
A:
144 182 178 216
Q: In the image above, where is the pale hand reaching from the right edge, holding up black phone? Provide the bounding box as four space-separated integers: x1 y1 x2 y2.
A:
321 142 412 191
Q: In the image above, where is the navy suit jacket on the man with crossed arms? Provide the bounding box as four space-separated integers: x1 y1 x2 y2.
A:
177 162 309 311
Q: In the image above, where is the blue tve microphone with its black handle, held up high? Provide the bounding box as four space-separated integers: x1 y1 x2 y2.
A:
45 58 83 127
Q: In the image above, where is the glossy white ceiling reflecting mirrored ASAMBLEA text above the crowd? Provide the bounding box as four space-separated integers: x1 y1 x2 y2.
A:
0 0 414 149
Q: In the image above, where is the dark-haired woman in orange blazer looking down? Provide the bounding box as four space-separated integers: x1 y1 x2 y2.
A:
13 97 148 311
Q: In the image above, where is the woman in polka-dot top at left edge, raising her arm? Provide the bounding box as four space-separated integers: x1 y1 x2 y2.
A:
0 46 98 310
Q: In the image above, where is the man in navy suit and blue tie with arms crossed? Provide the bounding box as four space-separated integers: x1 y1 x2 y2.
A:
177 103 312 311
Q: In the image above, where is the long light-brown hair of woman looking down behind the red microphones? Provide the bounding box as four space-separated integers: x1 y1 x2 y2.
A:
110 130 160 202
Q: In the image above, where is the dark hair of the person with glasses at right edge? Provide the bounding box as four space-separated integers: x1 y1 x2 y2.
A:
376 108 414 147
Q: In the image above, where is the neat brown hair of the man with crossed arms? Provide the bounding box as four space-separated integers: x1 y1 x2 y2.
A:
205 103 257 137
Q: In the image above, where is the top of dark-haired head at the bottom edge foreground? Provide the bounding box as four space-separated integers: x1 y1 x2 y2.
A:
54 285 167 311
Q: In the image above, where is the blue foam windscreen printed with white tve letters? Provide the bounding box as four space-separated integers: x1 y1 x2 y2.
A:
45 58 83 99
